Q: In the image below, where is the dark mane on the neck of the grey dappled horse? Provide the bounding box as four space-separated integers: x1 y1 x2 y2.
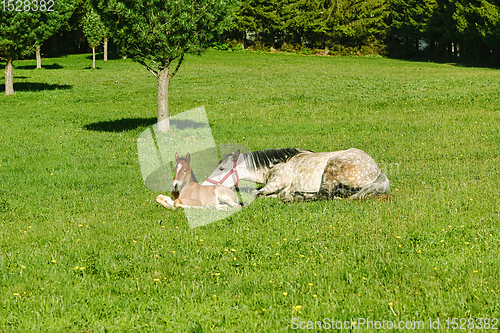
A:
243 148 312 170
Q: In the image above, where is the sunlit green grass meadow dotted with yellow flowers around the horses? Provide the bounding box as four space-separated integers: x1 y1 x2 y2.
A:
0 51 500 332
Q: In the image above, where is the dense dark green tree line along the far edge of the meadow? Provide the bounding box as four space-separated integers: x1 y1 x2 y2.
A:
3 0 500 60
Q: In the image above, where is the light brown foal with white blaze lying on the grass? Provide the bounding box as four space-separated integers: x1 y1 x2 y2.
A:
156 153 238 210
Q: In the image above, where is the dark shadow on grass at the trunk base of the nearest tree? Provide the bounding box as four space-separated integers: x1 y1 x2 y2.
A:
83 118 208 132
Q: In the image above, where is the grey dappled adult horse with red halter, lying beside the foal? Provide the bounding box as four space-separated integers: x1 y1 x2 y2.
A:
203 148 390 201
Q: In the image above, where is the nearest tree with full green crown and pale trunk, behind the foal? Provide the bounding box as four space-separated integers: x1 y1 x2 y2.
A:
91 0 239 132
